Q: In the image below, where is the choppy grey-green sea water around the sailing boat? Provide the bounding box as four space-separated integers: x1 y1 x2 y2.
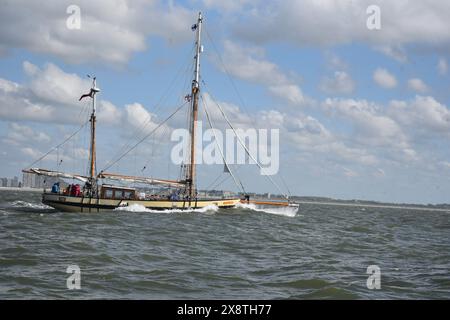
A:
0 192 450 300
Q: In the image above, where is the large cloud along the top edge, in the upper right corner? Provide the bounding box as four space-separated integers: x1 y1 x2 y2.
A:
234 0 450 60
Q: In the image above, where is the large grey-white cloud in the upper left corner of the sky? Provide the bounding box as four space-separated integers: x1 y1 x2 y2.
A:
0 0 195 65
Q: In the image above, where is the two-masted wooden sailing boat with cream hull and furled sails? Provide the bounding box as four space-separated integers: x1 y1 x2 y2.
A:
22 13 296 212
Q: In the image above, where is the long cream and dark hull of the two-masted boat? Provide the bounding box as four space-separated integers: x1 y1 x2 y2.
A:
42 193 240 212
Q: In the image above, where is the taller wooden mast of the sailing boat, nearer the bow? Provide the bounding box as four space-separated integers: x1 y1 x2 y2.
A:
188 12 202 199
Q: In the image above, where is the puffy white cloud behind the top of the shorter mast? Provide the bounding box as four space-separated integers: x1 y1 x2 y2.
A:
0 61 120 124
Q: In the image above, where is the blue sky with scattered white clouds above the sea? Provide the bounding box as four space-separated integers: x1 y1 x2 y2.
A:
0 0 450 203
